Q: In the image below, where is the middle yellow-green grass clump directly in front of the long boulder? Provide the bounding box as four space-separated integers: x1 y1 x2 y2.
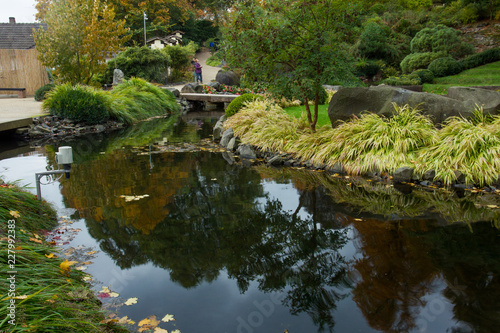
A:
319 104 436 175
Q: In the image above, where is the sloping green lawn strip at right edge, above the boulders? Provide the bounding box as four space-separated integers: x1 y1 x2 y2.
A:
423 61 500 95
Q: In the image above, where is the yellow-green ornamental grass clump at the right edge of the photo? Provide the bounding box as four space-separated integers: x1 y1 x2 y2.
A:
415 108 500 186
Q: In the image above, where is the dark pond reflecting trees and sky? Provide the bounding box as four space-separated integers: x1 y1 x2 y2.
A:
0 114 500 333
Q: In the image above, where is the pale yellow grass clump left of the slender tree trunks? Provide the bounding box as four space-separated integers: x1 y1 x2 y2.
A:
224 100 308 151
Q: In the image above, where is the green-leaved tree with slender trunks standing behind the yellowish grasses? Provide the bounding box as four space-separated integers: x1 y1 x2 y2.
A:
223 0 359 131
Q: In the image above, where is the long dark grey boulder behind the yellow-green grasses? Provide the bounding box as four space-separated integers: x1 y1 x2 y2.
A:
328 86 475 126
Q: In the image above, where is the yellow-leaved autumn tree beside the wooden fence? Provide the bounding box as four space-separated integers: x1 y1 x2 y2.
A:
33 0 129 84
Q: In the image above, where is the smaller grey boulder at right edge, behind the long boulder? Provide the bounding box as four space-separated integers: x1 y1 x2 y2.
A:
447 87 500 114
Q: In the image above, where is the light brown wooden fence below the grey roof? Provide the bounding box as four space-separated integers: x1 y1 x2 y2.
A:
0 49 49 96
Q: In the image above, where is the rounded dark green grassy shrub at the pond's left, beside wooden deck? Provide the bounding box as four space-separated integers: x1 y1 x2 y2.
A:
42 84 109 124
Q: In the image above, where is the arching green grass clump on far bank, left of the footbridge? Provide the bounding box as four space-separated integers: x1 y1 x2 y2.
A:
109 78 179 124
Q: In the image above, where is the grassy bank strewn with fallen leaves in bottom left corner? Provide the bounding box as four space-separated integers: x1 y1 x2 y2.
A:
0 180 126 333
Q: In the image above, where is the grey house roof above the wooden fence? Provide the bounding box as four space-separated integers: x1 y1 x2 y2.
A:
0 23 46 50
